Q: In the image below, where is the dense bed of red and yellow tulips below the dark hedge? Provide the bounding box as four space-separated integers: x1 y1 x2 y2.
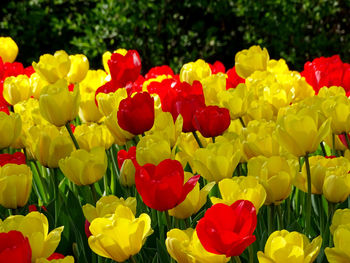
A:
0 37 350 263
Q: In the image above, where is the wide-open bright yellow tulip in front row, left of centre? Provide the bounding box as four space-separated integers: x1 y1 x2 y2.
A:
89 206 153 262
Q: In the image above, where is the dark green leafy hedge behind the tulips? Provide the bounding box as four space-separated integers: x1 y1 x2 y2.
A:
0 0 350 73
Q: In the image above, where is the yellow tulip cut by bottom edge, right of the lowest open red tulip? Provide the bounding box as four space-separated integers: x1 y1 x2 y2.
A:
258 230 322 263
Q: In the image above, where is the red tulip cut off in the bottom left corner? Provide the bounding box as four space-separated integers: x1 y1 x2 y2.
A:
0 230 32 263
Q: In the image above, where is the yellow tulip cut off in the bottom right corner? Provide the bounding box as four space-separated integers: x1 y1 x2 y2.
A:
324 225 350 263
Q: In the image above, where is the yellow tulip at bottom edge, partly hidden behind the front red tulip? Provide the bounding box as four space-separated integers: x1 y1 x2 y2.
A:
165 228 230 263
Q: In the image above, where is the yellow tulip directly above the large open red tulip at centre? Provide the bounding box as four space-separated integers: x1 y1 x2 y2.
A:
136 135 172 166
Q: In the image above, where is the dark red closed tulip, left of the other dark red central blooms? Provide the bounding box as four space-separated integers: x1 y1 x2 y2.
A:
117 92 154 135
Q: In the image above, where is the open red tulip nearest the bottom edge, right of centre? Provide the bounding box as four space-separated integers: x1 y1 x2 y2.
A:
196 200 257 257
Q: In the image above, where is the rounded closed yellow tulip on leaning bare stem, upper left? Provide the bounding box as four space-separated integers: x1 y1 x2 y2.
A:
39 79 80 127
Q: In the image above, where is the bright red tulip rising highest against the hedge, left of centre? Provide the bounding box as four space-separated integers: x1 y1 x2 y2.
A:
107 50 141 87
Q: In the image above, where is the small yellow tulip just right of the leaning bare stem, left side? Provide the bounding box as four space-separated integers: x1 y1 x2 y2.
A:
74 123 114 151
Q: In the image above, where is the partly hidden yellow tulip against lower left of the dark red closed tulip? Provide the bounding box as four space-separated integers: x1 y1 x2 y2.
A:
104 109 134 145
